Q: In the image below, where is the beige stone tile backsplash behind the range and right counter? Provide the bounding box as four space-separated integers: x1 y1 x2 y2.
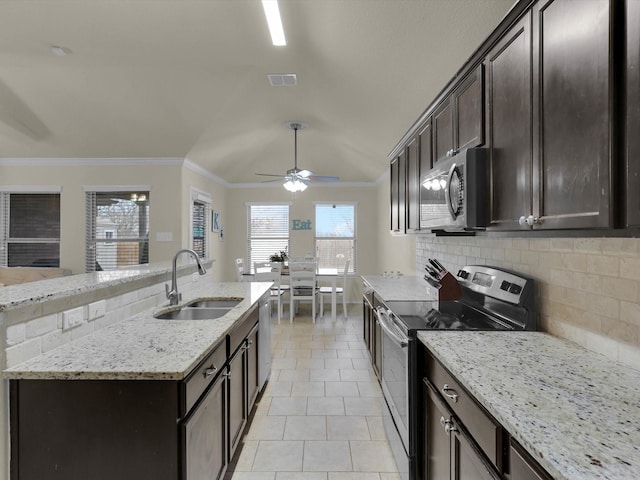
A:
416 235 640 369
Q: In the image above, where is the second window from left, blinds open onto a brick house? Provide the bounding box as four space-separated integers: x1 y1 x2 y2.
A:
85 187 149 272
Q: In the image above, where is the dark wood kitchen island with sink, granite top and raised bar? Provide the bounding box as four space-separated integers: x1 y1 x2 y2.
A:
0 266 271 480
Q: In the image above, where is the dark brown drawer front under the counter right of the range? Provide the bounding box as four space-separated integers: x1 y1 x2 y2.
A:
426 354 502 471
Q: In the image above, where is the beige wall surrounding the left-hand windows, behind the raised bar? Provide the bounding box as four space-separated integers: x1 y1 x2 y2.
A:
0 160 225 273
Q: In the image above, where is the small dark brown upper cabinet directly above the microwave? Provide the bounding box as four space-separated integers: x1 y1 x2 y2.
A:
432 65 484 162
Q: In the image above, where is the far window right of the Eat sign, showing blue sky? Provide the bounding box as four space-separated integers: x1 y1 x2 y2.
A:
316 203 356 273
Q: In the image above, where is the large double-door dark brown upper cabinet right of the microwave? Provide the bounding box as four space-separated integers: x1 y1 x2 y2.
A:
485 0 614 230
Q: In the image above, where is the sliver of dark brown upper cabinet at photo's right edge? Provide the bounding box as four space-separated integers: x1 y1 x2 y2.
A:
624 1 640 227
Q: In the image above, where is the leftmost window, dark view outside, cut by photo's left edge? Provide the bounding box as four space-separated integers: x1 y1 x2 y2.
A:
0 192 60 267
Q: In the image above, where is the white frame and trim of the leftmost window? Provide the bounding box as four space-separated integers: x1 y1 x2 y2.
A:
0 185 62 268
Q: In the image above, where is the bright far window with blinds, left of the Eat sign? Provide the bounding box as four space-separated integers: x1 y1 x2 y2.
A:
247 204 289 270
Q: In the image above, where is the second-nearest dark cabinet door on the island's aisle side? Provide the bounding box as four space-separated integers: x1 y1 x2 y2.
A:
227 347 247 460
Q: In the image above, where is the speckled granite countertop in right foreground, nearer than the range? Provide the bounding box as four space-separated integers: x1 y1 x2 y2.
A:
418 331 640 480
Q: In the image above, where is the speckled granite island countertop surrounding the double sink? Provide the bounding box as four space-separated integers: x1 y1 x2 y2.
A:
3 282 271 380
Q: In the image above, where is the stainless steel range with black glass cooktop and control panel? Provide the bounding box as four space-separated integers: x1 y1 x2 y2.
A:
376 261 538 480
